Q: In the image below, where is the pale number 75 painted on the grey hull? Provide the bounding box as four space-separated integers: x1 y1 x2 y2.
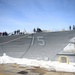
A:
28 36 45 46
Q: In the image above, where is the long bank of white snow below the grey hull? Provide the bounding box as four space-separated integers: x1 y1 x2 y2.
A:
0 53 75 72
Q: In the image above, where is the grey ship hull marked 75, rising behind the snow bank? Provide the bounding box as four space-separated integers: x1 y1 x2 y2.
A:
0 30 75 62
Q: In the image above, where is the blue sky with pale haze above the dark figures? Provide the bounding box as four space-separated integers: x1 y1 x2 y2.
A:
0 0 75 32
